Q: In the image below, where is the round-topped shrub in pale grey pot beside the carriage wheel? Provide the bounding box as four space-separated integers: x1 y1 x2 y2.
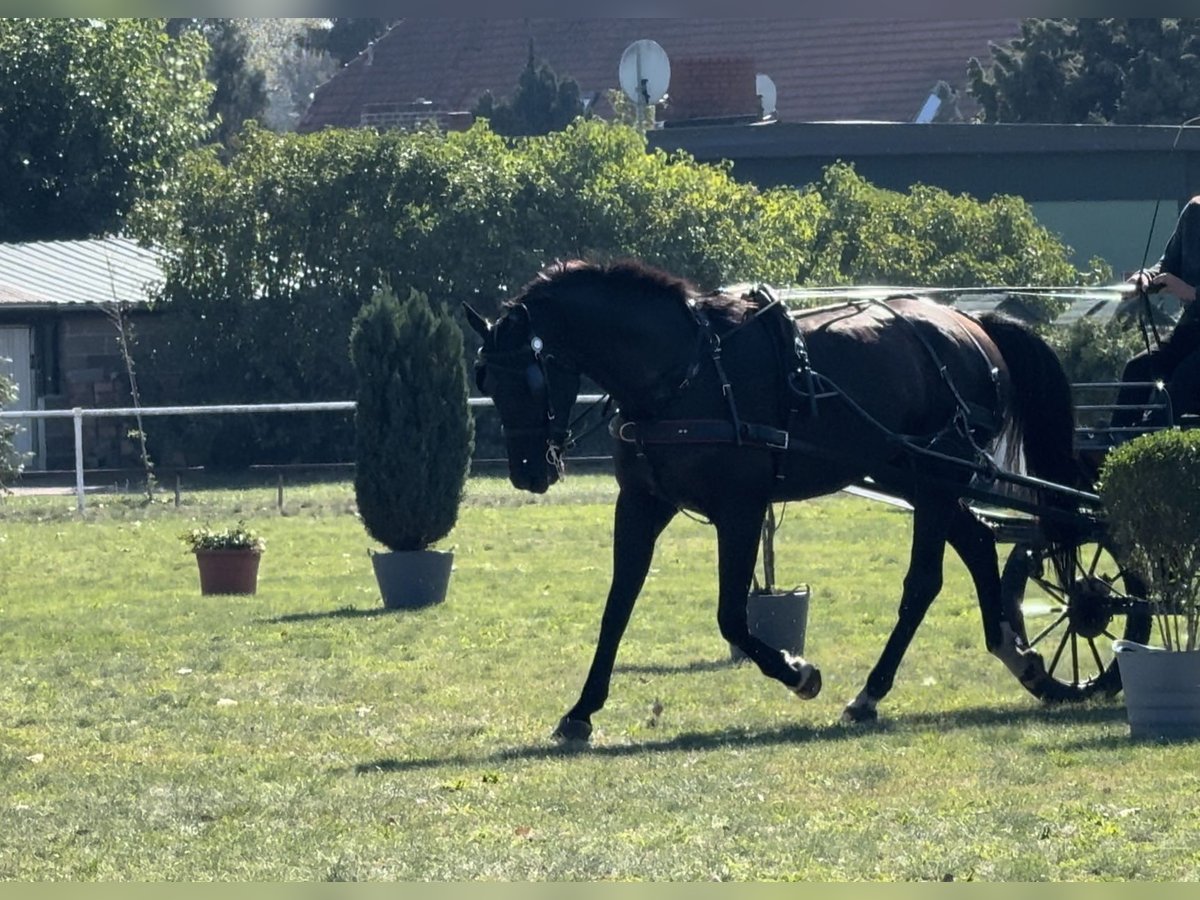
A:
1100 428 1200 737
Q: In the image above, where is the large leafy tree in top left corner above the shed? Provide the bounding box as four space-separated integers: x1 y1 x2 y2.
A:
0 18 212 241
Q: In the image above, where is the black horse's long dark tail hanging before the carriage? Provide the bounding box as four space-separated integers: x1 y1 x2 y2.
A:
979 312 1091 502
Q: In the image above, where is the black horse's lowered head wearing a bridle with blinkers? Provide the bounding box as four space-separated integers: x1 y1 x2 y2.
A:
466 304 580 493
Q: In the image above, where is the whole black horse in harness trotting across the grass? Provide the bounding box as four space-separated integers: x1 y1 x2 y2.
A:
467 256 1079 740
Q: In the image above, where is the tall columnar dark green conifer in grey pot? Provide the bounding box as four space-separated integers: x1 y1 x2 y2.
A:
350 288 475 608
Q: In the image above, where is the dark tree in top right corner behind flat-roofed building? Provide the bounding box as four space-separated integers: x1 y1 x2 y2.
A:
967 19 1200 125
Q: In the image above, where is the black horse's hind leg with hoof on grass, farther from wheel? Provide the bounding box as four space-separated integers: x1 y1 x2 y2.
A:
841 494 958 722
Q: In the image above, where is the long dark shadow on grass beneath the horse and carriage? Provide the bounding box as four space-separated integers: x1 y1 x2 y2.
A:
350 703 1129 775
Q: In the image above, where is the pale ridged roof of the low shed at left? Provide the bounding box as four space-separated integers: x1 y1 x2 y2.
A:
0 238 163 308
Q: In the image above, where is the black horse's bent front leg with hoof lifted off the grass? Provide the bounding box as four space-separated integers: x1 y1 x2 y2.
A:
714 504 821 700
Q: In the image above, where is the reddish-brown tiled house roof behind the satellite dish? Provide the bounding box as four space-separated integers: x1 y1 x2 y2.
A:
300 18 1020 131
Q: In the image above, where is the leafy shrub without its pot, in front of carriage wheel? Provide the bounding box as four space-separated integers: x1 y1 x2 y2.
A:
1100 430 1200 650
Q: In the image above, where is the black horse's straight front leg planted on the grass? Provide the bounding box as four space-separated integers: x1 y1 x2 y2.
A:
554 487 676 742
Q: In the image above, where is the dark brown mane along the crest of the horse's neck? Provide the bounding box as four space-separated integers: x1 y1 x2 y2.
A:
505 259 757 324
